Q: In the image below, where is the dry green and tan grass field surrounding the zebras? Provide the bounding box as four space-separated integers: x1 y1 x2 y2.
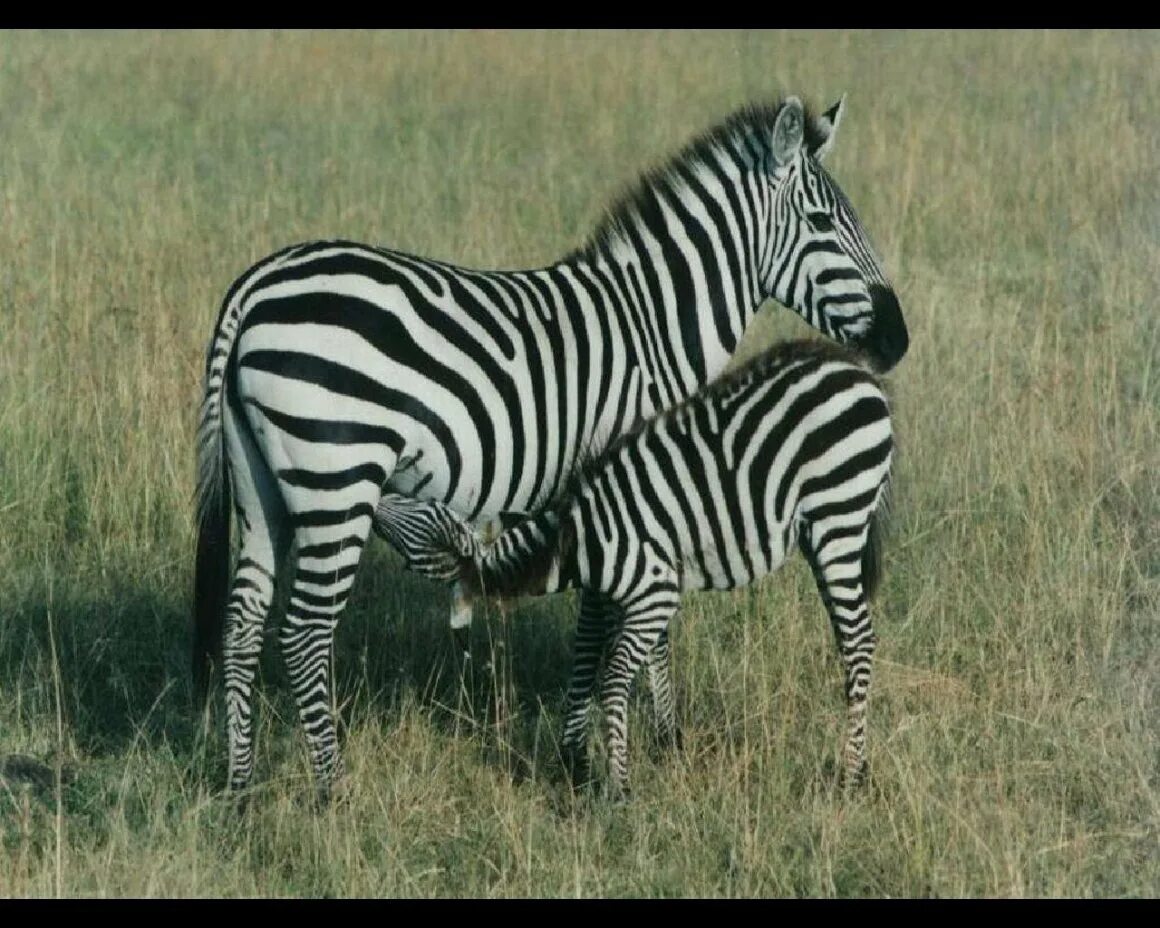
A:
0 32 1160 897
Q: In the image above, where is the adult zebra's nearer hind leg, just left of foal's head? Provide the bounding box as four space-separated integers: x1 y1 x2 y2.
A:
278 503 378 802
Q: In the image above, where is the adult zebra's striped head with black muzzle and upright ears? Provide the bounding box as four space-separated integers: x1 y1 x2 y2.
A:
761 96 909 371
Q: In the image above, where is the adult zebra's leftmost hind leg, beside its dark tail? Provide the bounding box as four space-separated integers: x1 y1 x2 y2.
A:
222 416 290 791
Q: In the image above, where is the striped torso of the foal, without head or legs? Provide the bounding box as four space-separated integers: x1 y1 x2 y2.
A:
579 341 893 589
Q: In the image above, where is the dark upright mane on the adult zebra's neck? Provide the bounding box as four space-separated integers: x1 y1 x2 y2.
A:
565 100 825 261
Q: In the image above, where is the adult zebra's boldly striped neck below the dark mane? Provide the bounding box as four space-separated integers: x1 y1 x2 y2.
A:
558 147 767 418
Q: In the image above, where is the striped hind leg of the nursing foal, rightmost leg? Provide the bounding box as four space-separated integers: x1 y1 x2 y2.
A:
799 525 877 789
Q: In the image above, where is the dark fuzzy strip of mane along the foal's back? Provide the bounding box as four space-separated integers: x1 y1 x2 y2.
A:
561 339 885 514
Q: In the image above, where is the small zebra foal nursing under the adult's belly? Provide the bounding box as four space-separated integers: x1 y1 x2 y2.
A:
373 341 894 795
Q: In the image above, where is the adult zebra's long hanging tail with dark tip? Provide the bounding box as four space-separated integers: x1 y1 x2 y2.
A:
193 312 233 706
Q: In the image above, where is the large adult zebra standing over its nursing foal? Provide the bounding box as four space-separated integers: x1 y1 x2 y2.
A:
194 97 907 795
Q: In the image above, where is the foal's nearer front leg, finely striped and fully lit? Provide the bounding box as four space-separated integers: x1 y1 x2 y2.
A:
601 582 680 802
